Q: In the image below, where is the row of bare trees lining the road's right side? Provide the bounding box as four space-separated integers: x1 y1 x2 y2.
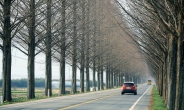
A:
115 0 184 110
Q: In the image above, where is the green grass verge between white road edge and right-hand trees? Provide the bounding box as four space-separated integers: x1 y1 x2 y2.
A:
149 85 168 110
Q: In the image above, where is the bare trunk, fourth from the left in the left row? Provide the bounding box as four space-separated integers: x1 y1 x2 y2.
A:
59 0 66 95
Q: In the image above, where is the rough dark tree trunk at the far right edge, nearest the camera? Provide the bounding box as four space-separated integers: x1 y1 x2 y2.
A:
175 6 184 110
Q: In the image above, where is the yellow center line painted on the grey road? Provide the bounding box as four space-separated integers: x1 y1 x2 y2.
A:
59 94 117 110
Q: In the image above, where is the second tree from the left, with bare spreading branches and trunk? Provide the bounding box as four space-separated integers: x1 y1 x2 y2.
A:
13 0 45 99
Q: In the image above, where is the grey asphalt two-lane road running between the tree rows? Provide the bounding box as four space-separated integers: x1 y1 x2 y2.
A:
0 84 152 110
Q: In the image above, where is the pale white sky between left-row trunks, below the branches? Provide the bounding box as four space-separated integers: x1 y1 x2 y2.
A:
0 48 102 81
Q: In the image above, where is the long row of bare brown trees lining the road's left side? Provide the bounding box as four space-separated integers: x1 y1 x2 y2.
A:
0 0 146 101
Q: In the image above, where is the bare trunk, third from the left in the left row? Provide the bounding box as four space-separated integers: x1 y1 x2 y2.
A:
45 0 52 96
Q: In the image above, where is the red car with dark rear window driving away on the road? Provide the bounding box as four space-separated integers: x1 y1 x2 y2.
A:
121 82 137 95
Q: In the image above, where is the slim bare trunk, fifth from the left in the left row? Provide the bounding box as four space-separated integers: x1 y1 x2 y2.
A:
71 0 77 94
